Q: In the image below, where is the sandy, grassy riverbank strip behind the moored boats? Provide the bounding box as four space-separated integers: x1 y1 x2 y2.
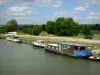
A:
0 34 100 49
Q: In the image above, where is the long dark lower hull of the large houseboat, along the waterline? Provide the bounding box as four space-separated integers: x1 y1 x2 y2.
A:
45 48 89 59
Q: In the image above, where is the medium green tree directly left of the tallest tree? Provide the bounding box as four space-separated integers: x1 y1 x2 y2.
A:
46 21 55 34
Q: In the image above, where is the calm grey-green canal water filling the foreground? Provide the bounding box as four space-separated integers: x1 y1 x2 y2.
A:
0 40 100 75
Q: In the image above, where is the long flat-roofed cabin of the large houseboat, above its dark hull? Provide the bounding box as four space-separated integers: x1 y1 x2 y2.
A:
47 43 90 54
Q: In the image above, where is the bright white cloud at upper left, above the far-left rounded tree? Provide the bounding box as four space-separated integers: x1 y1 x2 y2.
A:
7 6 37 17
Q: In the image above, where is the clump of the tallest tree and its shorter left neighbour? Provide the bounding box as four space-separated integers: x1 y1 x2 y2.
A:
46 17 80 36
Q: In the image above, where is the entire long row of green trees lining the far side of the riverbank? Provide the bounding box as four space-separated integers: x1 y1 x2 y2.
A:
0 17 92 36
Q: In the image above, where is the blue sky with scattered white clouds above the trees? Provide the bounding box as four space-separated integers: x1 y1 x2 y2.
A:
0 0 100 24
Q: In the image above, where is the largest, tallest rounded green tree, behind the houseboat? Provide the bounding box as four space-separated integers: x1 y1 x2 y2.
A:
55 17 79 36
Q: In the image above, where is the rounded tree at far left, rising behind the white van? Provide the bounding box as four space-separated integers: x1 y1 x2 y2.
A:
7 19 18 32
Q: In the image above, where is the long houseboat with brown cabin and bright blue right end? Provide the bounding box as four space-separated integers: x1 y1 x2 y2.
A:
45 43 92 59
